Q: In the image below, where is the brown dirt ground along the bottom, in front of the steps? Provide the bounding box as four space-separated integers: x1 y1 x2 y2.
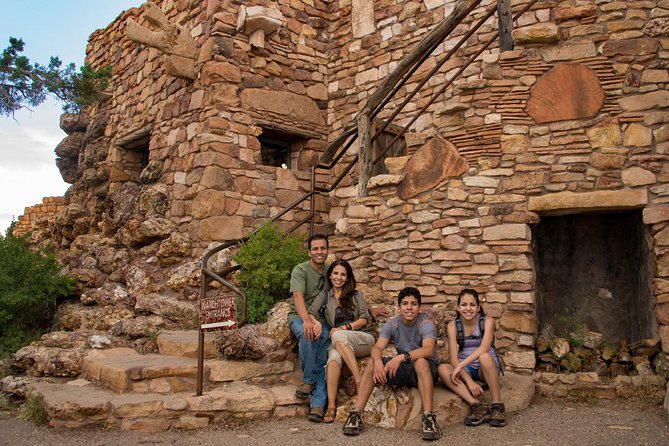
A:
0 400 669 446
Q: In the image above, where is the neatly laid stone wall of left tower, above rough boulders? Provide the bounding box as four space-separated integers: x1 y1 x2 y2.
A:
76 0 334 246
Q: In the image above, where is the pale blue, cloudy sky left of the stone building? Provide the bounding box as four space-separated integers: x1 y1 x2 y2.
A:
0 0 143 235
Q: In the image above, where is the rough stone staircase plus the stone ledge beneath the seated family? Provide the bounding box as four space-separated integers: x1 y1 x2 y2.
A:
18 331 534 431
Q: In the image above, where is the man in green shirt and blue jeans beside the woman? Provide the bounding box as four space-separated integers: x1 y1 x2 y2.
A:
288 234 330 421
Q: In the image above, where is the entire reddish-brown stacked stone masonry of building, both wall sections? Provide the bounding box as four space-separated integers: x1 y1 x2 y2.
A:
9 0 669 412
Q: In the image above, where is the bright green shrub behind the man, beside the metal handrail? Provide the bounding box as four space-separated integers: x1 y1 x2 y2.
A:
235 222 308 323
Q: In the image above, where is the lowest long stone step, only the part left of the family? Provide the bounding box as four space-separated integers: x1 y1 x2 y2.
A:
32 379 307 431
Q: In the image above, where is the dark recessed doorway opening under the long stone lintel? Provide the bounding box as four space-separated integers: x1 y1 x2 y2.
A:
532 210 658 343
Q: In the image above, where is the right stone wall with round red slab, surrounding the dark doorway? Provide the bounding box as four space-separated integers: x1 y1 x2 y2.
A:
320 0 669 369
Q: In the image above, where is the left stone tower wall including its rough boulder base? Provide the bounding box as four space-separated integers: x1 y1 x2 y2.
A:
34 0 340 332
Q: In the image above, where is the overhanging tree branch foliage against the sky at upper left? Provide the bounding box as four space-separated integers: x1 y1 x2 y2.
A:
0 37 111 116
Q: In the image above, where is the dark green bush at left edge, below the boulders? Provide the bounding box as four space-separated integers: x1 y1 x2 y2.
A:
0 227 74 358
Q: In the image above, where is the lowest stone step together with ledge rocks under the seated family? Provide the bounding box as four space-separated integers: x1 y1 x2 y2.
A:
32 373 534 431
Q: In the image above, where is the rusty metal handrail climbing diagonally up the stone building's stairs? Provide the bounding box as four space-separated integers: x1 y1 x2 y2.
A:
197 0 538 395
